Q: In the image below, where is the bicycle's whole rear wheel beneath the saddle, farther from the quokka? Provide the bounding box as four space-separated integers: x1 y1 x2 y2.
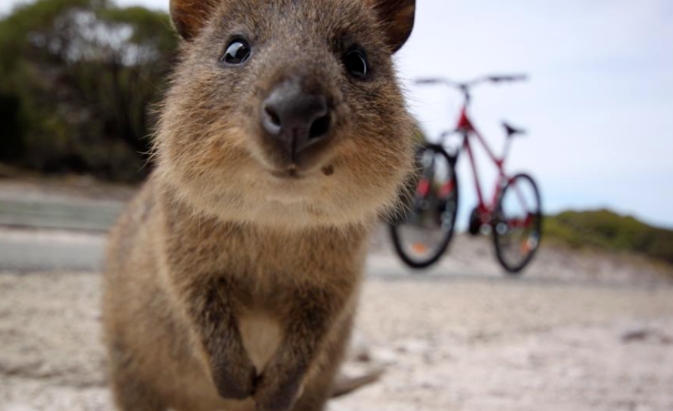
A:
493 174 542 274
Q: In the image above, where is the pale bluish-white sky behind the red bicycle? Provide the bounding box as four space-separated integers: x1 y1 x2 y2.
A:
0 0 673 227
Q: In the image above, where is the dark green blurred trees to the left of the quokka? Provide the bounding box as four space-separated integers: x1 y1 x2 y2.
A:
0 0 178 182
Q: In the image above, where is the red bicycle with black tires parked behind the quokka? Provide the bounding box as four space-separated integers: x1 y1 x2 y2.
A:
390 75 542 274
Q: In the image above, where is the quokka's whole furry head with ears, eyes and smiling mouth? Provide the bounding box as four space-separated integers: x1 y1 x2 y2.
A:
158 0 414 227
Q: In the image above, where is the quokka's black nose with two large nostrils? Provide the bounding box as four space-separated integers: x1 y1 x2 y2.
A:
261 81 330 160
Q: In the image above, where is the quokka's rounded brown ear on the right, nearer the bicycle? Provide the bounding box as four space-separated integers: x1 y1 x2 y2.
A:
367 0 416 53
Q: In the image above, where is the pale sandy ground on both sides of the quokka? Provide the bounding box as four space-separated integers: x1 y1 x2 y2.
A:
0 273 673 411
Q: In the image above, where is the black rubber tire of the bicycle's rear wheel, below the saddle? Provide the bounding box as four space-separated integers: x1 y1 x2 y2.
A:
492 173 543 275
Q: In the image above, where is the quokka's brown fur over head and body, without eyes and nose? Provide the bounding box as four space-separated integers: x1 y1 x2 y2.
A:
103 0 414 411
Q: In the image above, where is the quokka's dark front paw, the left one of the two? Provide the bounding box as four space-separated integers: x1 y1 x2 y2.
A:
213 358 257 400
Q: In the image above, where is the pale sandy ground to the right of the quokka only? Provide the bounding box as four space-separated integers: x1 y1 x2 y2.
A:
333 281 673 411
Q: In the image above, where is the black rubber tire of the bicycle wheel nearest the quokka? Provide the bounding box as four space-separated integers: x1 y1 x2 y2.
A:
389 143 459 269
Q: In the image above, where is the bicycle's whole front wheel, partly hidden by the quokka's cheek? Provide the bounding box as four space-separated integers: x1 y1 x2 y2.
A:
390 144 458 268
